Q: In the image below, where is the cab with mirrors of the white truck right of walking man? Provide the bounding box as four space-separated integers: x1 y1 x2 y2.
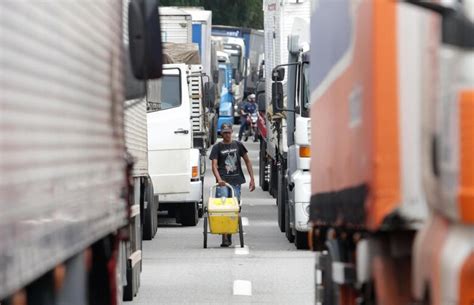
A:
270 35 311 249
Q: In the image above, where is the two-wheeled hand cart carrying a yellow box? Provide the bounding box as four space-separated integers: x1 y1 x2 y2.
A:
203 183 244 248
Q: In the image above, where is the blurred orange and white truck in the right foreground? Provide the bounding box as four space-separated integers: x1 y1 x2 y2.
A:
310 0 474 305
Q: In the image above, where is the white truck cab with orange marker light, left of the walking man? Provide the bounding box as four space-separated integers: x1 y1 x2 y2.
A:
147 63 203 226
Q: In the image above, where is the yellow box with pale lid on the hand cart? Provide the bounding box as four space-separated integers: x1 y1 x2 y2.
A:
207 197 240 234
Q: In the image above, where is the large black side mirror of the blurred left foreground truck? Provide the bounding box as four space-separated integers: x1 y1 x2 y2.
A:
128 0 163 80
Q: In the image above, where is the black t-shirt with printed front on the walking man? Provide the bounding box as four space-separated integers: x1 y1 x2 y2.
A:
209 141 247 185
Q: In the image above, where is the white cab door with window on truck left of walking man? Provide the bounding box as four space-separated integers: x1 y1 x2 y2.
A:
147 65 192 194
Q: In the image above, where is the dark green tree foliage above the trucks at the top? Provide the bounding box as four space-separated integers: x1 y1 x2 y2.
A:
160 0 263 29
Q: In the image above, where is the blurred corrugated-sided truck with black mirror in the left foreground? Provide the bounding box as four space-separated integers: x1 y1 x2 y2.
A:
0 1 161 305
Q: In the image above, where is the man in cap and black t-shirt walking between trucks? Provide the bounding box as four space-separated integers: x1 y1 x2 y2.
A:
209 124 255 247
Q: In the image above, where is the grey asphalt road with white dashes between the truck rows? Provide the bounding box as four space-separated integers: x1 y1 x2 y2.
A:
130 133 314 305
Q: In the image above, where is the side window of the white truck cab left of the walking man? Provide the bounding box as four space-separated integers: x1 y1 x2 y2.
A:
147 75 181 112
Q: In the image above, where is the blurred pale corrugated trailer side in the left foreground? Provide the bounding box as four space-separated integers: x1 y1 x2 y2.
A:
0 1 127 299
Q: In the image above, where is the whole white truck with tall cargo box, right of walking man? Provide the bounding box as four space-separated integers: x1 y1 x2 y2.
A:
258 0 311 248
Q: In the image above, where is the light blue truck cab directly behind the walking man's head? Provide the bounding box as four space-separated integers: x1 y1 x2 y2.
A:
217 63 234 134
